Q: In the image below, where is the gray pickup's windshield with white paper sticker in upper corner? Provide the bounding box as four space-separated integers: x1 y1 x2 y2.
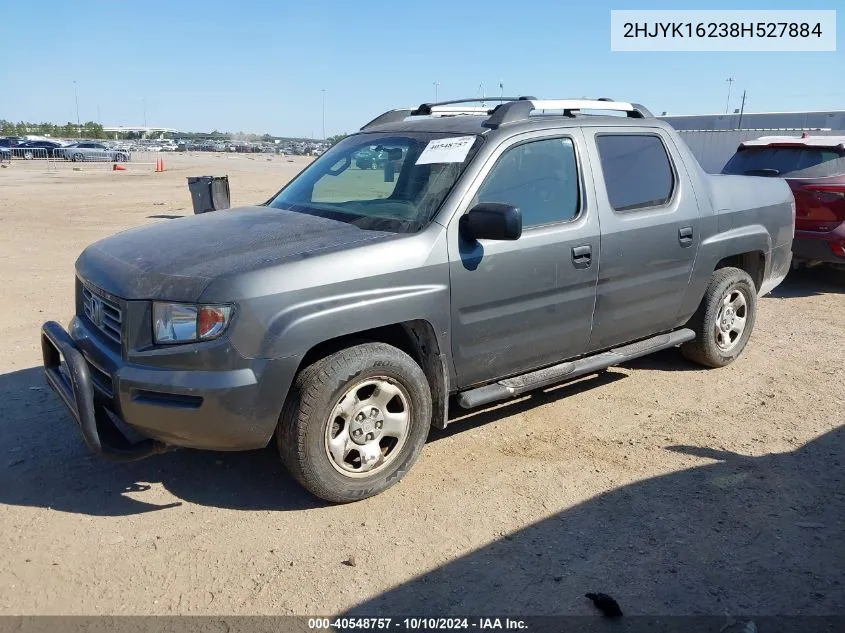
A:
269 133 482 233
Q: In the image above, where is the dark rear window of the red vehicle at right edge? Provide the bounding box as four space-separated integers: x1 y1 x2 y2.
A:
722 146 845 178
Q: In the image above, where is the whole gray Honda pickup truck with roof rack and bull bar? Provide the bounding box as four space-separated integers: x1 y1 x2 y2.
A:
41 97 794 502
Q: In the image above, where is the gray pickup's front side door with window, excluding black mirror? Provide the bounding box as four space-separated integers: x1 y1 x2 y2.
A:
449 130 600 388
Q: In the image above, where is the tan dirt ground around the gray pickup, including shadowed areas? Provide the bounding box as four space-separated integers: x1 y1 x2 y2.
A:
0 154 845 616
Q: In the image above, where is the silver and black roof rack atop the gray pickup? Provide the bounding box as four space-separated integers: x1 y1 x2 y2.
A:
361 96 653 130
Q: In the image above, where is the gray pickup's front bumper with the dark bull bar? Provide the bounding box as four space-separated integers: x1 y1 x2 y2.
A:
41 317 296 460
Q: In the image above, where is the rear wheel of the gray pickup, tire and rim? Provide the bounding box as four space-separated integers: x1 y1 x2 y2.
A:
681 268 757 367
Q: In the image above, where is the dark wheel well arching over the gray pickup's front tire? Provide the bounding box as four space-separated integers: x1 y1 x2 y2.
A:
297 320 449 429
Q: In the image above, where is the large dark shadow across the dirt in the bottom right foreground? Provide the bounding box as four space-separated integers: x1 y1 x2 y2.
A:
344 426 845 616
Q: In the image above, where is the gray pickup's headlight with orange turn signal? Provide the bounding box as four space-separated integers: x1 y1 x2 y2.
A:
153 301 232 343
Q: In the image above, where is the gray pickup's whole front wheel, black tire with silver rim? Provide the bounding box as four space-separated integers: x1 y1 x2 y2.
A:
276 343 431 503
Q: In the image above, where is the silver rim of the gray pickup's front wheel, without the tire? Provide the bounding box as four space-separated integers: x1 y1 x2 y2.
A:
325 376 412 477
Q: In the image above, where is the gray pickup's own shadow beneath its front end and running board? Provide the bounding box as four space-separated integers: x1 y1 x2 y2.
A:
0 367 624 516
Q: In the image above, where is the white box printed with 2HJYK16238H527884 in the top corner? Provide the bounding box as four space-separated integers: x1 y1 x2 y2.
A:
610 9 836 51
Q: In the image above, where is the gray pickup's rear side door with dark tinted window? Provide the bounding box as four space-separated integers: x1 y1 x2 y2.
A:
584 126 700 351
